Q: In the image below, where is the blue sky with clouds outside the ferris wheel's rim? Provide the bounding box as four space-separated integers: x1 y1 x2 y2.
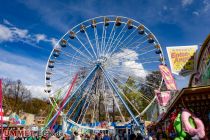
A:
0 0 210 96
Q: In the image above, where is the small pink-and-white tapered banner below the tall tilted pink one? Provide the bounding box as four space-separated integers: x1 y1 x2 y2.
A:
155 90 171 106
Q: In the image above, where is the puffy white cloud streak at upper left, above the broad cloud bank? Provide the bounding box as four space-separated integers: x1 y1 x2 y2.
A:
0 19 57 46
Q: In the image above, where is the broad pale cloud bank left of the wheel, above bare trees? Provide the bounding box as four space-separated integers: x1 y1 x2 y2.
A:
0 49 45 98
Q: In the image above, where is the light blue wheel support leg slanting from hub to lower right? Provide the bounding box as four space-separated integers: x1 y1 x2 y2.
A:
101 67 144 136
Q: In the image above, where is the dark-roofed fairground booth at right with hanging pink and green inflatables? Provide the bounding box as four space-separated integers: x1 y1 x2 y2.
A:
159 35 210 138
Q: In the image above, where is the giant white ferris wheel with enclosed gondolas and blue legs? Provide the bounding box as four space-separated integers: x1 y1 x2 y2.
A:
45 16 165 135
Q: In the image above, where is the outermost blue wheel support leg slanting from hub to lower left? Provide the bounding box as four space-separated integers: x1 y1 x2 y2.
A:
43 65 99 127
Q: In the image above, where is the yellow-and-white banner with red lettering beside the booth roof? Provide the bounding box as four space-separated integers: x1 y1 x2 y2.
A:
166 45 198 76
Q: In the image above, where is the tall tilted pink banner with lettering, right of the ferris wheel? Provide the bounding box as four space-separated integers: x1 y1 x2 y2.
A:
159 65 177 90
